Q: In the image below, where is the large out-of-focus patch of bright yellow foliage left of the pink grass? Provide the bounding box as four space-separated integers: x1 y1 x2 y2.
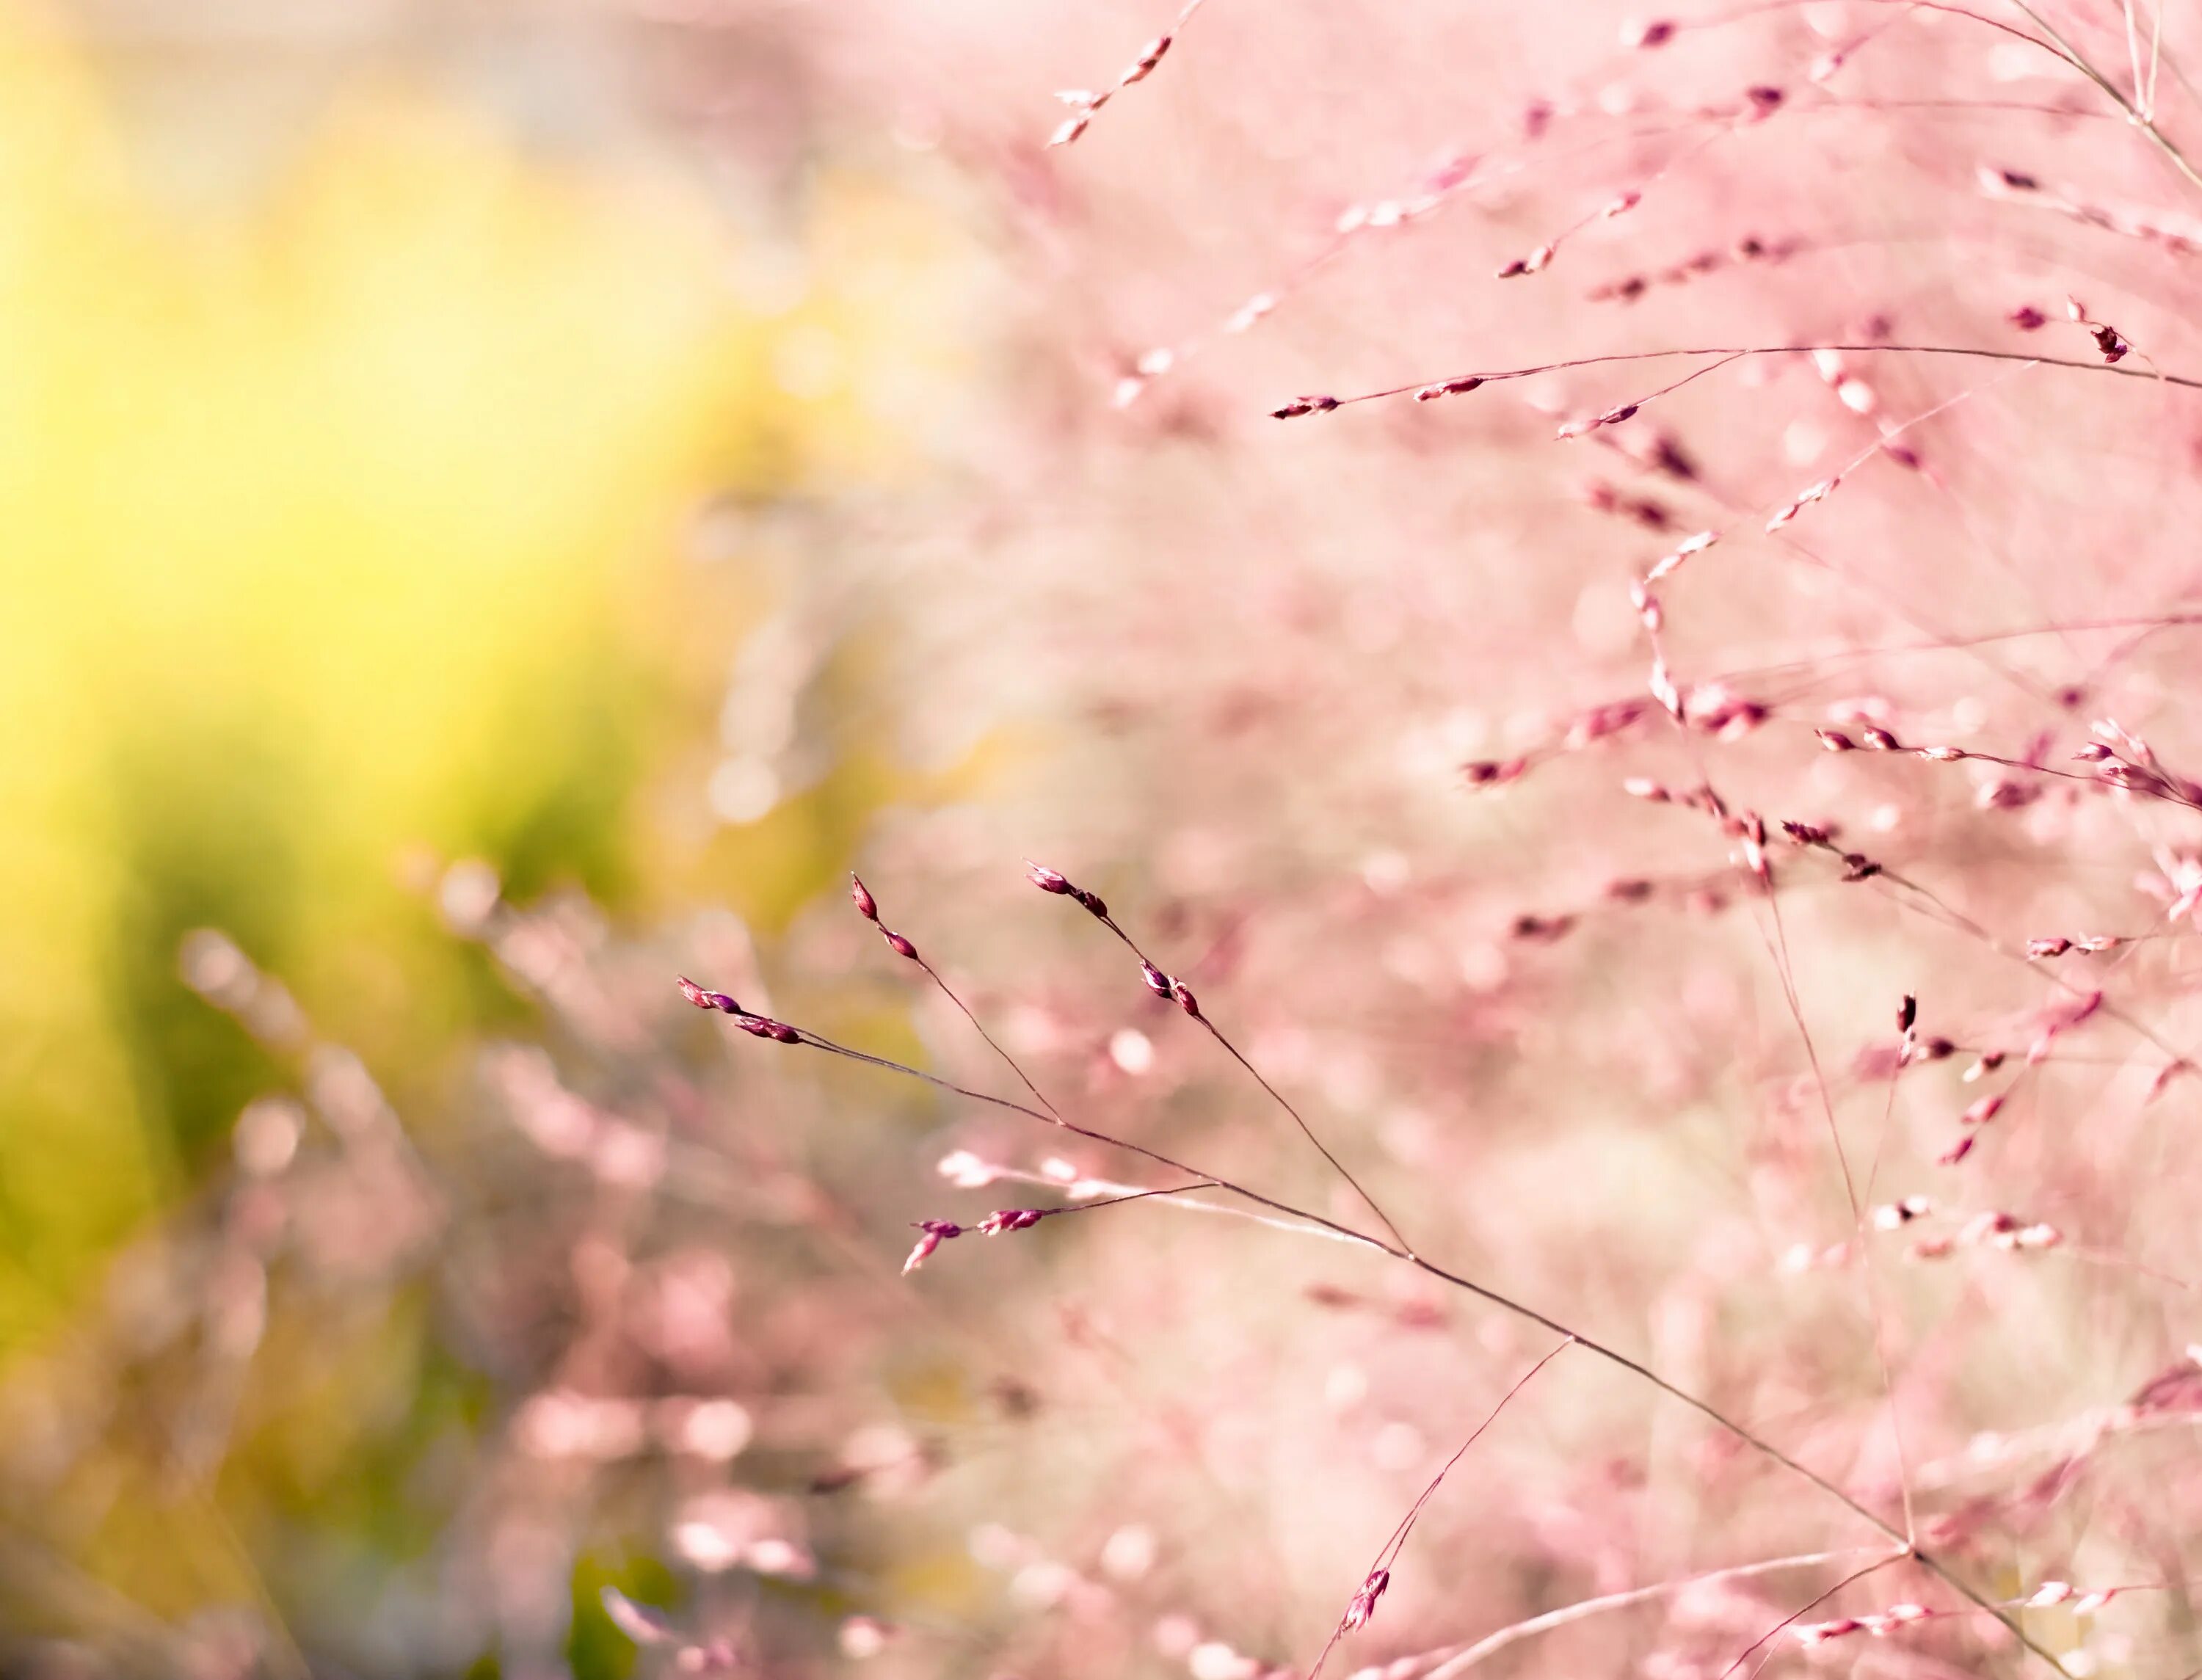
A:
0 7 949 1359
